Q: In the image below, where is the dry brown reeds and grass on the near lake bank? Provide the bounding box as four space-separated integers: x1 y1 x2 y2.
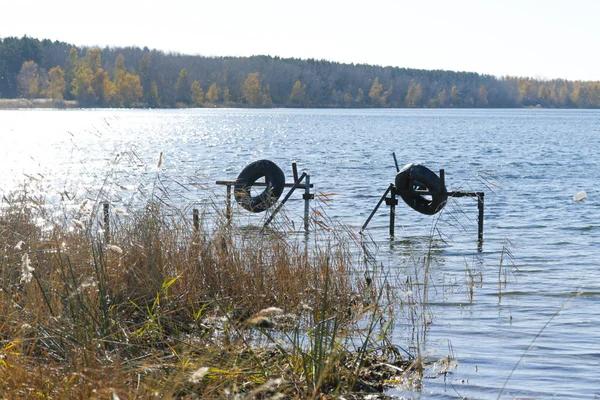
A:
0 188 419 399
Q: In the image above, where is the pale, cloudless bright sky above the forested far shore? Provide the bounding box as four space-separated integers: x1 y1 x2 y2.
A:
0 0 600 80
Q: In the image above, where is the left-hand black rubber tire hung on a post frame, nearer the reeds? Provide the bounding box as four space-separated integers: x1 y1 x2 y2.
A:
233 160 285 213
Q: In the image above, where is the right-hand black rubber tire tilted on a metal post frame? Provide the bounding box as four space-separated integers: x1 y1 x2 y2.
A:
396 164 448 215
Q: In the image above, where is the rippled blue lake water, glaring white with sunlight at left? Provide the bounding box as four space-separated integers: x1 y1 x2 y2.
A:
0 109 600 399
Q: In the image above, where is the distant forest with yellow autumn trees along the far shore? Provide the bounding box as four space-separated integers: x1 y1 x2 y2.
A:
0 36 600 108
